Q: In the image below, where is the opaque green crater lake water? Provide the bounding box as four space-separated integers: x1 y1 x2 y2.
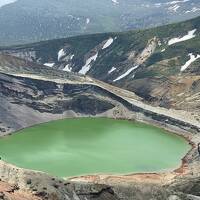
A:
0 118 191 177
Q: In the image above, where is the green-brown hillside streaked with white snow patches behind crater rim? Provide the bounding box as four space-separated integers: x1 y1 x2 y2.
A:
1 17 200 115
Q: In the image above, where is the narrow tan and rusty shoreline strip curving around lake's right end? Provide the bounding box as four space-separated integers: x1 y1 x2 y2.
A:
66 115 197 184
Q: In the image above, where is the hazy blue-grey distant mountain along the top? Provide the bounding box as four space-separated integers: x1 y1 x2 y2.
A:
0 0 200 45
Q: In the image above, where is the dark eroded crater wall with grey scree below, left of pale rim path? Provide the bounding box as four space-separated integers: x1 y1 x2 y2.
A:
0 74 125 134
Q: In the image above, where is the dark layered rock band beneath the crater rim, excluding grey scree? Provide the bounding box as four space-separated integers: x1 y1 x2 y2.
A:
0 75 114 114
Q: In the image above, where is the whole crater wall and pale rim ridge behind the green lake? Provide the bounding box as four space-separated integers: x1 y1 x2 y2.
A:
0 52 200 134
